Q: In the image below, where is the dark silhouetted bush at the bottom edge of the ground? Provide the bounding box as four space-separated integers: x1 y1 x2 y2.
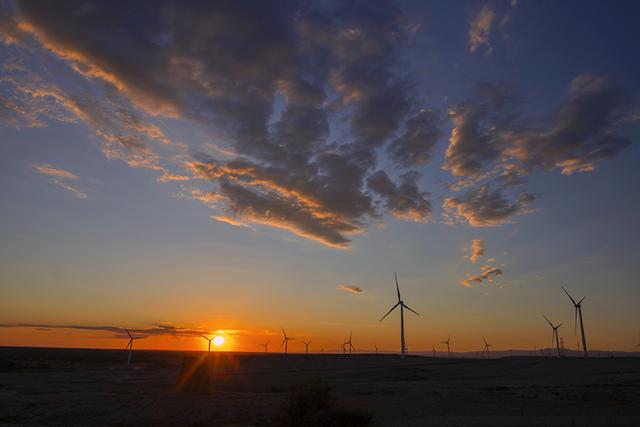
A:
273 381 371 427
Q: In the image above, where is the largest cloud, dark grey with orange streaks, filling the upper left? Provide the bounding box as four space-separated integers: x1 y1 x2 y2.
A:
3 1 439 248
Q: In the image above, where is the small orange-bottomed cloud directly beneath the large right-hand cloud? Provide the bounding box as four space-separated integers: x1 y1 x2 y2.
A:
442 186 535 227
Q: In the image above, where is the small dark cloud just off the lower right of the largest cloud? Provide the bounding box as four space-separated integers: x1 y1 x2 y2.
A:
367 171 431 222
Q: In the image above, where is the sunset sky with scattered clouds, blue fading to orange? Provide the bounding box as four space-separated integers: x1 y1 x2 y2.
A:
0 0 640 351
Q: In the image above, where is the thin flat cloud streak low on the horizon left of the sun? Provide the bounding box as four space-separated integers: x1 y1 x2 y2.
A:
0 323 220 339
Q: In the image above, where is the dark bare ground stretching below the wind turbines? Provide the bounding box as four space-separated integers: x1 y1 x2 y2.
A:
0 348 640 427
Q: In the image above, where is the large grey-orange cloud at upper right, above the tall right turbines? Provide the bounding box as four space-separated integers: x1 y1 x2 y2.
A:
443 74 633 185
